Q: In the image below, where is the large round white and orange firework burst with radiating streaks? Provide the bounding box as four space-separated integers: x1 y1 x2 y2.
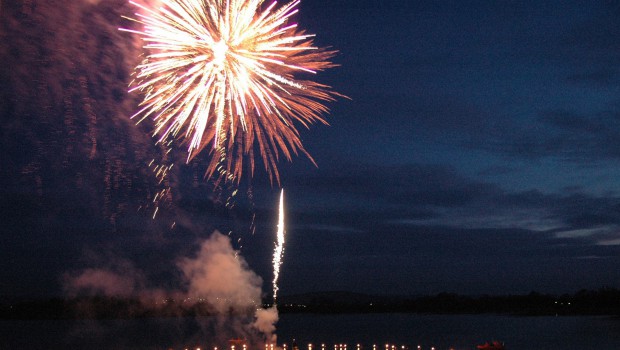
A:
121 0 339 185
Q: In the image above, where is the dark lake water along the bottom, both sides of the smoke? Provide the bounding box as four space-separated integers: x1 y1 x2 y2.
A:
0 314 620 350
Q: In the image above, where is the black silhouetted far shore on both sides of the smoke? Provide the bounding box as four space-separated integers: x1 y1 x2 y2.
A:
0 288 620 320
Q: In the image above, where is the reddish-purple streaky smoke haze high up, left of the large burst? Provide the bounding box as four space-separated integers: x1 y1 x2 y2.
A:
0 0 172 226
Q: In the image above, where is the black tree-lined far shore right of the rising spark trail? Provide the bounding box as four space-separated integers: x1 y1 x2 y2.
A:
278 288 620 315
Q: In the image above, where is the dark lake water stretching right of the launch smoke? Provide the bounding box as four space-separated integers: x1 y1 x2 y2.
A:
278 314 620 350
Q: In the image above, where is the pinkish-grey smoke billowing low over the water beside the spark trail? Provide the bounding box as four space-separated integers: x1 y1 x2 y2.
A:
64 231 278 344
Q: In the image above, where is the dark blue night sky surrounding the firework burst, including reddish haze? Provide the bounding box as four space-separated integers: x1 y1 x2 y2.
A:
0 0 620 297
